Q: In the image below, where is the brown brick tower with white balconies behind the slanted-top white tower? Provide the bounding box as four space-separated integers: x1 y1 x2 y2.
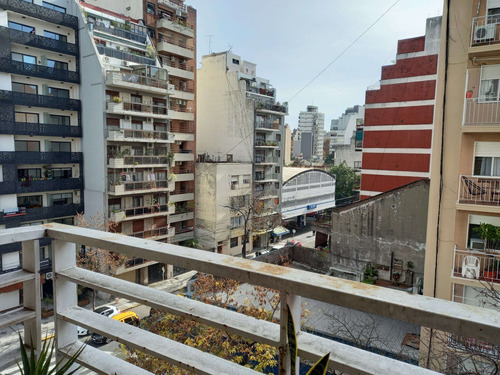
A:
92 0 196 247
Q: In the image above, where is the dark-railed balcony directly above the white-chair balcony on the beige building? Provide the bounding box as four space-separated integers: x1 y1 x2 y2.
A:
458 176 500 212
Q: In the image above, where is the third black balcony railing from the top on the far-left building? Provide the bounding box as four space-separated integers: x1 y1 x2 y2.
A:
0 58 80 83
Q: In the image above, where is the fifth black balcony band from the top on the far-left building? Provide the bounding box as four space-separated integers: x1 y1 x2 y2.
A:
0 121 82 138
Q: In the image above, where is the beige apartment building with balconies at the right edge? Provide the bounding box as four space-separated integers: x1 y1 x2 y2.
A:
424 0 500 320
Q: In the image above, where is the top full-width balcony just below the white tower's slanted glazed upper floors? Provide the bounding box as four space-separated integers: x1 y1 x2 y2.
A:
106 71 173 96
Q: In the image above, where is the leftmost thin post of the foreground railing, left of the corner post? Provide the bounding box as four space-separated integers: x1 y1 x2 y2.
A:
22 240 42 353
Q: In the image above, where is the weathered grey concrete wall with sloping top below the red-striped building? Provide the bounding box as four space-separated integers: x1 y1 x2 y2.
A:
331 180 429 276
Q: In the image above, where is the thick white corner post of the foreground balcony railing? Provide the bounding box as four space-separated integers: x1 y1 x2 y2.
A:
52 240 78 369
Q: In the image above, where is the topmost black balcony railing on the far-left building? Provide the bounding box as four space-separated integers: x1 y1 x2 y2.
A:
0 0 78 30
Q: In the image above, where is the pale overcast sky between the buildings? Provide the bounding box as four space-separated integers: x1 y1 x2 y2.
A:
186 0 443 130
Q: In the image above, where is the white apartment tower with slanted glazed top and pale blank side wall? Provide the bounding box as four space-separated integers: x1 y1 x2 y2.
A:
80 2 179 284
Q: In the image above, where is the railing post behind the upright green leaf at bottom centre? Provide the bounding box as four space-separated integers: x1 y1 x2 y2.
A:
278 292 302 375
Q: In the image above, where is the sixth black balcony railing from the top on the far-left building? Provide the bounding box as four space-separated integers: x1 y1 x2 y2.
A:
0 151 83 164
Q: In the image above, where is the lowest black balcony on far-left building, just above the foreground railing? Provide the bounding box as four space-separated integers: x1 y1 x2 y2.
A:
0 203 83 224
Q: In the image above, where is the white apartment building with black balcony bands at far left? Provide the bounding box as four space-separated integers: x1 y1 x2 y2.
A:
0 0 83 310
